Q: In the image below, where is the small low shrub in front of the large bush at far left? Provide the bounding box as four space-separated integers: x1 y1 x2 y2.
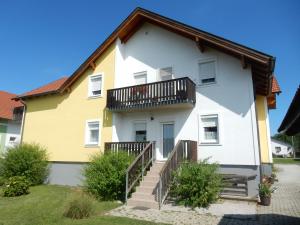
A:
3 176 29 197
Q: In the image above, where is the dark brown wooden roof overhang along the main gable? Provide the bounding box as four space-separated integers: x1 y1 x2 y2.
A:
59 8 275 96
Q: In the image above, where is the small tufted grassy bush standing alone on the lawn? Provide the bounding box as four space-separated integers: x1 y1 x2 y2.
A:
64 194 94 219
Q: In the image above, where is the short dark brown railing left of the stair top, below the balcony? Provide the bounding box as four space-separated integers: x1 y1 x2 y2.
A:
104 141 149 156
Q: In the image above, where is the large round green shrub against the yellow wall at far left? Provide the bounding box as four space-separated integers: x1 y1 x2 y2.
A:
3 144 48 185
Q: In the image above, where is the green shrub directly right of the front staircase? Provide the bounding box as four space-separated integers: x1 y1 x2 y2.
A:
170 160 222 208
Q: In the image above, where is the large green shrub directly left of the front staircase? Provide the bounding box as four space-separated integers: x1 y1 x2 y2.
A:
84 152 133 200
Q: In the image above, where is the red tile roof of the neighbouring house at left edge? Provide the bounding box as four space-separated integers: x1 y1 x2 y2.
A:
0 91 23 120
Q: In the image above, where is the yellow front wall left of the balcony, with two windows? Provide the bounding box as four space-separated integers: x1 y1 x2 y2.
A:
23 45 115 162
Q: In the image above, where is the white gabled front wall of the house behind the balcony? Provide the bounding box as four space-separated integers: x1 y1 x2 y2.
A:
113 23 259 165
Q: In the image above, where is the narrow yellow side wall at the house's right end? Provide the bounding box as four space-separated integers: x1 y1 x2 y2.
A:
255 95 272 163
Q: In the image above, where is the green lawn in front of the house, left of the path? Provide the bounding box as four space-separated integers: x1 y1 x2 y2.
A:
0 185 162 225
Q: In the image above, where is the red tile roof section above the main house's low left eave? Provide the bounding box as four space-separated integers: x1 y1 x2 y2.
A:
17 77 68 98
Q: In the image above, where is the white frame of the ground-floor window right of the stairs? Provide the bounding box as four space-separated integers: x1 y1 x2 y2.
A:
199 113 221 145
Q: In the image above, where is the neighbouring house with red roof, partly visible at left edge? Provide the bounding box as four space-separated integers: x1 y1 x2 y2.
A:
0 91 24 155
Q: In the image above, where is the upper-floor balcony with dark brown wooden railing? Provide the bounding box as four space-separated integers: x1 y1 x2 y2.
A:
106 77 196 111
